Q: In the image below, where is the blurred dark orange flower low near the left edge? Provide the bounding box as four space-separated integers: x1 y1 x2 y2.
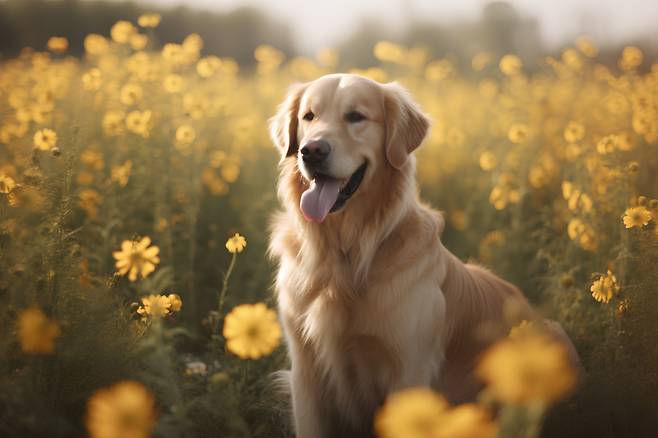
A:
18 308 61 354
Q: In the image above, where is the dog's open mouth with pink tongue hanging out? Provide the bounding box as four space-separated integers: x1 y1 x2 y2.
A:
299 163 367 222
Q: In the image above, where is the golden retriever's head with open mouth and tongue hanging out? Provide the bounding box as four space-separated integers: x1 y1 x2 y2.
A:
270 74 429 222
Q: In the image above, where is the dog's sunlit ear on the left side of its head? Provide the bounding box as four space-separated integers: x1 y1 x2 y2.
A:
270 84 307 158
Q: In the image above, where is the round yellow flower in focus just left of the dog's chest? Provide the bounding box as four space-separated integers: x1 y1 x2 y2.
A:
223 303 281 359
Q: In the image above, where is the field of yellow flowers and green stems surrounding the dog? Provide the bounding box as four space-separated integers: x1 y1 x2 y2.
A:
0 15 658 438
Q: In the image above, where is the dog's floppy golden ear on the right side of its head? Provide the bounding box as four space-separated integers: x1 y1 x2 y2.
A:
383 82 430 169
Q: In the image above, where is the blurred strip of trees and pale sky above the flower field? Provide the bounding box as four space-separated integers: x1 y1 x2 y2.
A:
0 0 658 68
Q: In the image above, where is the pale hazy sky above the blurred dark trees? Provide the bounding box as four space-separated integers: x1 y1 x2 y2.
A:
137 0 658 53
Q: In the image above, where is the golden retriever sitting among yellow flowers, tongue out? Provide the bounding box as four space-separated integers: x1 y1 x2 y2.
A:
269 74 564 438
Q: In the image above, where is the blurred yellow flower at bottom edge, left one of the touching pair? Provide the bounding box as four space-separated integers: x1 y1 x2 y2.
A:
375 388 448 438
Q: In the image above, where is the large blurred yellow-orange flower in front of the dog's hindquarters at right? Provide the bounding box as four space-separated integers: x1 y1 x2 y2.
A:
477 335 576 404
